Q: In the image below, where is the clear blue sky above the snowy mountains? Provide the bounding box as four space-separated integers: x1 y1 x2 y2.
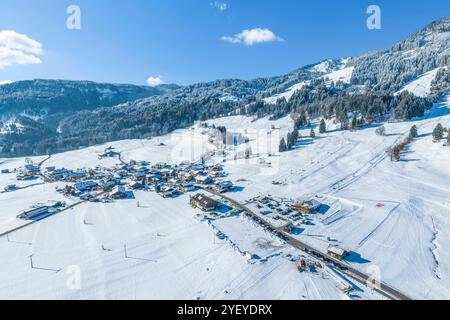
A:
0 0 450 84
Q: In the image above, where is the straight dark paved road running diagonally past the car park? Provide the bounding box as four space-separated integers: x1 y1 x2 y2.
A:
203 188 411 300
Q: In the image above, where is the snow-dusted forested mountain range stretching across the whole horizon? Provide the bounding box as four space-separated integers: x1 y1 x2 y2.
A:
0 19 450 157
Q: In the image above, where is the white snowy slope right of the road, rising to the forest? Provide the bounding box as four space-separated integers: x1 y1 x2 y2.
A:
208 97 450 299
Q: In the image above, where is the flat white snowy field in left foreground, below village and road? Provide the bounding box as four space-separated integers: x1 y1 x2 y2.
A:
0 192 380 299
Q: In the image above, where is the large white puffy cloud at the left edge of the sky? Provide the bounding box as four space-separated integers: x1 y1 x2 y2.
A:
0 30 44 69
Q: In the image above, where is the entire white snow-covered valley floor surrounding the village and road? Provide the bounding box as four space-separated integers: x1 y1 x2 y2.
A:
0 95 450 299
